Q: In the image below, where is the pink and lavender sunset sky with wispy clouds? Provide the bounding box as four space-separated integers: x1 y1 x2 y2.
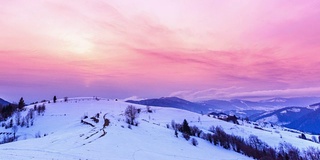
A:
0 0 320 101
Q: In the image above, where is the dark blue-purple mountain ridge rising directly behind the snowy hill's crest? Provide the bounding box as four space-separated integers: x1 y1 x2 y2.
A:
126 97 209 113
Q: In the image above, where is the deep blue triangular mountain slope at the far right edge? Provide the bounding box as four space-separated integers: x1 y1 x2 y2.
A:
286 108 320 134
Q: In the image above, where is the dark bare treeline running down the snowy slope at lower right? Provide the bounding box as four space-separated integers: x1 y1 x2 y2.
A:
171 120 320 160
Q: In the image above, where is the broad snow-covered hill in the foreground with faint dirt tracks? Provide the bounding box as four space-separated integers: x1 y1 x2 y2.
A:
0 98 320 160
